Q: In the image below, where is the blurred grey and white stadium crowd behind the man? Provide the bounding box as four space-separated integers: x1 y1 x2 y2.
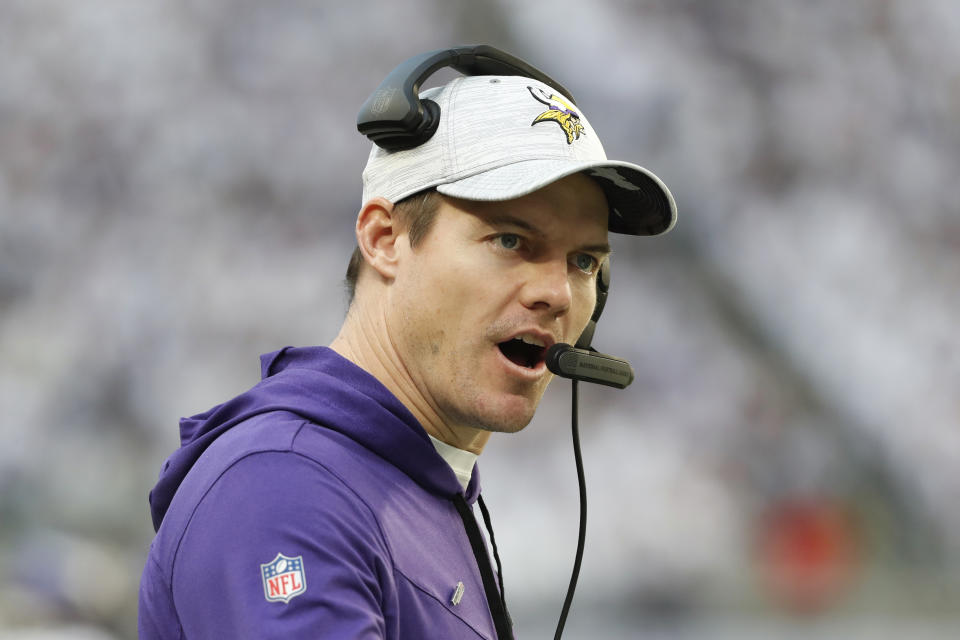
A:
0 0 960 640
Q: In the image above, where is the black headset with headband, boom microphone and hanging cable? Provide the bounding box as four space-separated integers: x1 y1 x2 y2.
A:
357 45 633 640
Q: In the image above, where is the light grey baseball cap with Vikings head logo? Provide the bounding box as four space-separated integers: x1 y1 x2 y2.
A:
363 76 677 236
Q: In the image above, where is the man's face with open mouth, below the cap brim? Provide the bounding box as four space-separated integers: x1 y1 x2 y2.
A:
386 174 609 432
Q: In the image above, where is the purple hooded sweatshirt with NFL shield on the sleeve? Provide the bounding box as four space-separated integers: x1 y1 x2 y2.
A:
139 347 510 640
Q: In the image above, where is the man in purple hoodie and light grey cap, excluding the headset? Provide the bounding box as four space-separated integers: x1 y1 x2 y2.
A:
140 52 676 640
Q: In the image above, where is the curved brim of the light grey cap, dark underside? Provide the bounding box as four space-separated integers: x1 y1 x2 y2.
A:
437 159 677 236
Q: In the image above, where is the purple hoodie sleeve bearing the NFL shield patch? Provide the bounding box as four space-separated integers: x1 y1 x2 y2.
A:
171 451 396 640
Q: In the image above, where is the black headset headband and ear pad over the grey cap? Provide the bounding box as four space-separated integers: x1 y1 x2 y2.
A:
357 45 573 151
